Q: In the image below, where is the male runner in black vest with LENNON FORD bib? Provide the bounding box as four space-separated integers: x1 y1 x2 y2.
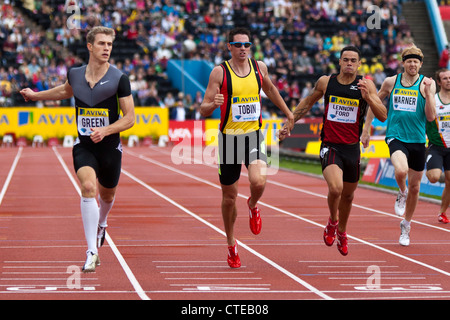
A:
279 46 387 256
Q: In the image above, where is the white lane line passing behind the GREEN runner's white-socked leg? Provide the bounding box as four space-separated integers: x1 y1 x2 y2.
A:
52 147 150 300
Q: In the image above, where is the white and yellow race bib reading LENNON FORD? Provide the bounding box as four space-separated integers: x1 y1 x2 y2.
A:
327 96 359 123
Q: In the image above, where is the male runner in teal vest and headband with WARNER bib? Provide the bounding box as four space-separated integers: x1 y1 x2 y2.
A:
361 45 436 246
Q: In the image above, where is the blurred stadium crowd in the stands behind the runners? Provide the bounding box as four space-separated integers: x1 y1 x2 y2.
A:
0 0 413 119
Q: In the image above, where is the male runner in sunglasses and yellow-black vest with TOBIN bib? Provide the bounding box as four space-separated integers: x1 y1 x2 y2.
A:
200 28 294 268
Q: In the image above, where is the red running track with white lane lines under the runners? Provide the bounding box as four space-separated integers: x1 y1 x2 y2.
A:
0 147 450 300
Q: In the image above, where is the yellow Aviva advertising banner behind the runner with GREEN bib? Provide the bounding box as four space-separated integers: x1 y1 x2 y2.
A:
0 107 169 139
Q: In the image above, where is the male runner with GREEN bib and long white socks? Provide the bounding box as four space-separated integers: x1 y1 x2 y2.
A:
20 27 135 272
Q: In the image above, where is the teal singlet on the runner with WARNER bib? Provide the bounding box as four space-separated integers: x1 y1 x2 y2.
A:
386 73 427 143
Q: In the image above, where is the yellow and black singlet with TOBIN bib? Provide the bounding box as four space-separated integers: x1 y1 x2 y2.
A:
220 59 263 134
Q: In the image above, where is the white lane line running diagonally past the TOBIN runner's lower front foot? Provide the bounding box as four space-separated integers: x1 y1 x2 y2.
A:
122 169 332 300
